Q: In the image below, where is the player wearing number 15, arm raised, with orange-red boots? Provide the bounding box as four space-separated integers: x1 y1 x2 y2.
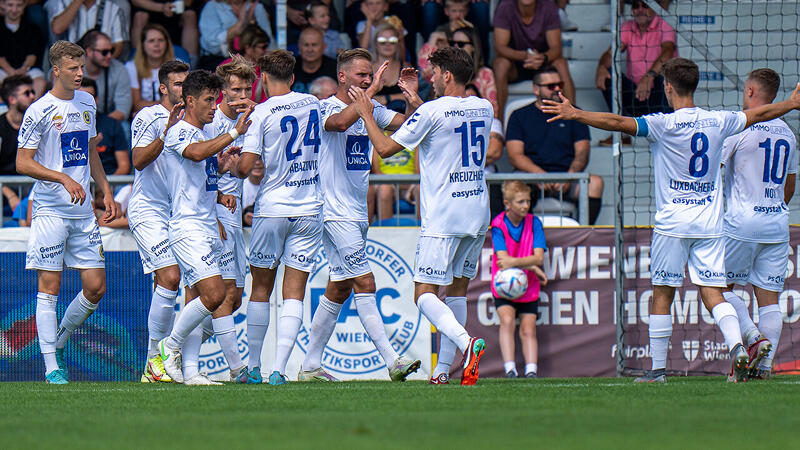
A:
349 47 494 385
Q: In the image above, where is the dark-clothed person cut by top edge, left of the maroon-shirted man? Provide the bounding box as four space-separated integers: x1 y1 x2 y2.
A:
422 0 491 57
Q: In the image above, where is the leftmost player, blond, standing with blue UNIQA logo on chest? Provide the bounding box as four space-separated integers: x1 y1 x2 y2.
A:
16 41 117 384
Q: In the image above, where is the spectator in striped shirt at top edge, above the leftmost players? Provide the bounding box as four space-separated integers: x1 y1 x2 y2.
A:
49 0 128 59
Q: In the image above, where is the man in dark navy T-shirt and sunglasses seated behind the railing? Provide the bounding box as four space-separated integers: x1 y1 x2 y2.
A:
506 67 603 224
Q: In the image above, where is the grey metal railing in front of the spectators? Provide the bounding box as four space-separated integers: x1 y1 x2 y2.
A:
0 172 589 225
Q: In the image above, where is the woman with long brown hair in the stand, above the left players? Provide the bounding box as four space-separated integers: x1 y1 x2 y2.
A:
125 23 175 114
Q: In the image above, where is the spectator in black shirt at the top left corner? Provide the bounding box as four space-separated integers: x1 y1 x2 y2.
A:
0 0 47 98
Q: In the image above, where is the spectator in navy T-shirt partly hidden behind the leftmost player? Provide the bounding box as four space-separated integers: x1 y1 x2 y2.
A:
81 78 131 176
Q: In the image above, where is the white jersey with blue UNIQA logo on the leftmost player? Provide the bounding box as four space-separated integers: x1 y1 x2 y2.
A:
17 91 97 219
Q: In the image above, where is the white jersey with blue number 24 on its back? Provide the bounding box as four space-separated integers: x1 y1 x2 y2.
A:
242 92 322 217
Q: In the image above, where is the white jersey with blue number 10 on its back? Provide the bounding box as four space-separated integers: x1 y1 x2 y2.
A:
722 119 797 244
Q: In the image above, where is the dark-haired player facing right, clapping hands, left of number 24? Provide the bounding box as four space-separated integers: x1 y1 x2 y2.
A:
158 70 252 385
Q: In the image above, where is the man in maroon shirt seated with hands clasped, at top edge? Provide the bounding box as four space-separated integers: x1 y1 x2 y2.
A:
494 0 575 119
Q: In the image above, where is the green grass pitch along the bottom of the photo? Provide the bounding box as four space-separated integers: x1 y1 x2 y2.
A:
0 376 800 450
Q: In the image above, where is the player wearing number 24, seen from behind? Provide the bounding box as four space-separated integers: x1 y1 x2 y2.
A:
238 50 322 385
